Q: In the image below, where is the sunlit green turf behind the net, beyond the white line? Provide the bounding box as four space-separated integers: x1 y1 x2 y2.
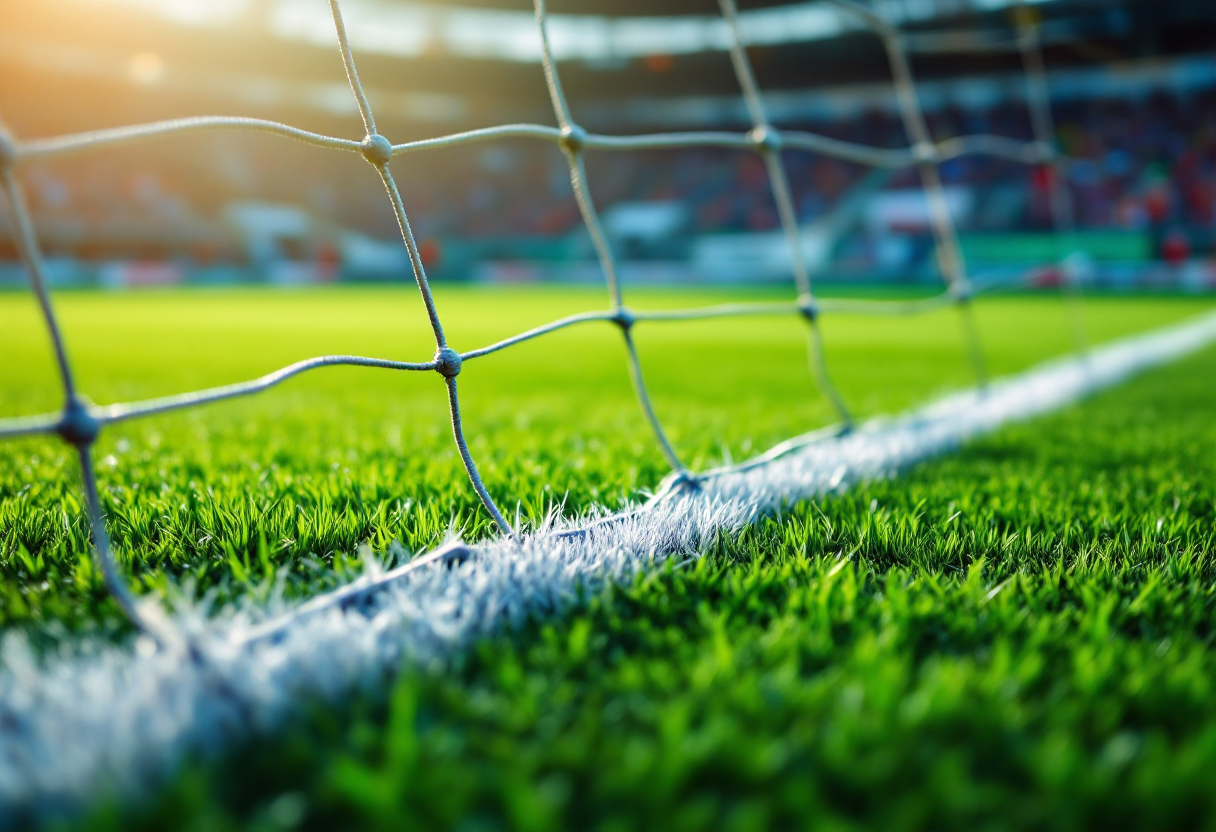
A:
0 286 1205 629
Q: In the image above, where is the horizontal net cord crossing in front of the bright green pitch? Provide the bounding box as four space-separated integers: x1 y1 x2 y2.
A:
0 266 1041 445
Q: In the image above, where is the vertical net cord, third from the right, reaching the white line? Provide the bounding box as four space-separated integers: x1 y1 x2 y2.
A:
717 0 852 429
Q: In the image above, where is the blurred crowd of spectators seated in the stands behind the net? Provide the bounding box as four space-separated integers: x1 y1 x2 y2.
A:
7 90 1216 260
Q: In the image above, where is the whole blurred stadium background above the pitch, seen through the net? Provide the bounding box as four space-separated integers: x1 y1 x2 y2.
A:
0 0 1216 291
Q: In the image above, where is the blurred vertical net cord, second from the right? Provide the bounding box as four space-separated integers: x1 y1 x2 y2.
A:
875 18 987 386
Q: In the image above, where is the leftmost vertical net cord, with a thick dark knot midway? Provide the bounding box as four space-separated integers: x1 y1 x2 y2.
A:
0 167 165 643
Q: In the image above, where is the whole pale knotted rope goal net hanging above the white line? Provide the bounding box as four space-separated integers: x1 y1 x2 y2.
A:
0 0 1085 643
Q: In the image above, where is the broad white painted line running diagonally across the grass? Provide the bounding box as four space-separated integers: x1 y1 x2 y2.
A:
0 313 1216 826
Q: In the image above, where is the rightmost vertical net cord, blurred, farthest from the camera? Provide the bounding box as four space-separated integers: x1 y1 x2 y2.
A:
1014 0 1090 354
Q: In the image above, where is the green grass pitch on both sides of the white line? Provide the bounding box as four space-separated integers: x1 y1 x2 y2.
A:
0 287 1216 830
